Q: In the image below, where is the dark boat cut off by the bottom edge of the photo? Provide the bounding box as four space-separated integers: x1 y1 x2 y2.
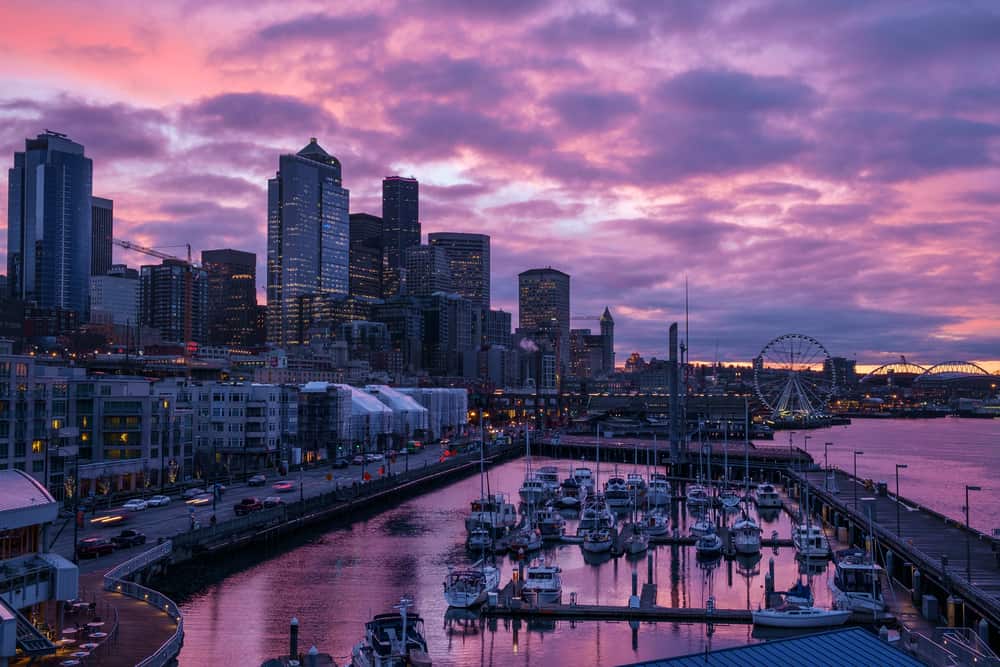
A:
351 598 431 667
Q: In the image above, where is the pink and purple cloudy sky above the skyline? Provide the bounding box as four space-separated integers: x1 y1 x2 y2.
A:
0 0 1000 364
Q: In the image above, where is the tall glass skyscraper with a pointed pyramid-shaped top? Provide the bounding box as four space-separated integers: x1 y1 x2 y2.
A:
267 138 350 345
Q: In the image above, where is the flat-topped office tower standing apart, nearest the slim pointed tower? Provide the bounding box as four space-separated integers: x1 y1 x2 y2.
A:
517 266 570 368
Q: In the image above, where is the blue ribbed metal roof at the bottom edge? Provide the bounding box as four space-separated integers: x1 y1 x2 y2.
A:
628 628 922 667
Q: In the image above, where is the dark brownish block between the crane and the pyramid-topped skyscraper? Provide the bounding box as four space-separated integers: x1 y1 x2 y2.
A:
201 248 257 345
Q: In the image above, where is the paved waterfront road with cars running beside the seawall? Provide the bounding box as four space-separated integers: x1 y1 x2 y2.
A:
48 445 450 573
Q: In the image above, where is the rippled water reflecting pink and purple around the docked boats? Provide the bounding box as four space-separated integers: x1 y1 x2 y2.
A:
179 419 1000 667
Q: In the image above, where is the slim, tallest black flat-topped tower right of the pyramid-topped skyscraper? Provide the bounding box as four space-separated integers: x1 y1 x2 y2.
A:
382 176 420 298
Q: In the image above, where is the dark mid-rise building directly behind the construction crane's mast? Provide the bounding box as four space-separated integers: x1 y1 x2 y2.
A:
139 259 208 343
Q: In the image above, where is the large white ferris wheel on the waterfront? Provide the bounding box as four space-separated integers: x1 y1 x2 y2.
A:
753 334 837 419
